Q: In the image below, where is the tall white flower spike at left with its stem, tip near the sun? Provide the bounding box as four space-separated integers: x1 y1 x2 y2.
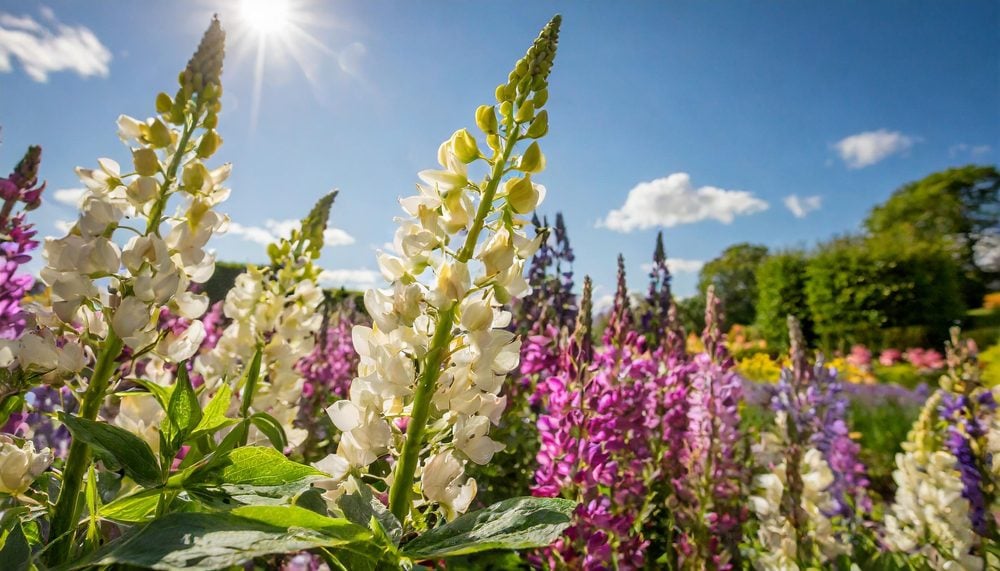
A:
41 19 230 564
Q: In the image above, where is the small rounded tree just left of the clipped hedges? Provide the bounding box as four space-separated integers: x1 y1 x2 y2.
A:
698 242 767 330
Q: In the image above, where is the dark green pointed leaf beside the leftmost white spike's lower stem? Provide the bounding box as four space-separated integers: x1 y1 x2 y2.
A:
59 413 162 488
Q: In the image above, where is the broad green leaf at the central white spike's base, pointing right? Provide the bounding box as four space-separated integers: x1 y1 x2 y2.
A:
402 497 576 560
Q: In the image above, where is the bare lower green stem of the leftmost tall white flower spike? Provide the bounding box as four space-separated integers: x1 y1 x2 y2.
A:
48 330 123 565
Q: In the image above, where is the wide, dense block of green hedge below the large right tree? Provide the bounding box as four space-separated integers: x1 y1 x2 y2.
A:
805 238 962 350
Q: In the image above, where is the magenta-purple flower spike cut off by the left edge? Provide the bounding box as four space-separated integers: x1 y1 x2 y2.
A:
0 146 45 339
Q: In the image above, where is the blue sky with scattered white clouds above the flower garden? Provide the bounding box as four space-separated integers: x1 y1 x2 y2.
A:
0 0 1000 306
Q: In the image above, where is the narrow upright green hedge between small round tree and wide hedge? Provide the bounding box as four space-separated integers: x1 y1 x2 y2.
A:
757 251 813 351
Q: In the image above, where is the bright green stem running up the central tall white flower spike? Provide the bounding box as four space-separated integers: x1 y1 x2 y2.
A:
389 113 520 522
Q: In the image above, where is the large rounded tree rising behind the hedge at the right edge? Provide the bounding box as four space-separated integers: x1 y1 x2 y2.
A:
865 165 1000 307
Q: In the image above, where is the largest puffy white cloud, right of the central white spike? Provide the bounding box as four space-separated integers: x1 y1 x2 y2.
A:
597 172 768 232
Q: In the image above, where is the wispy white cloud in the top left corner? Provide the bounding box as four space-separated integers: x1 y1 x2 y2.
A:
0 10 111 83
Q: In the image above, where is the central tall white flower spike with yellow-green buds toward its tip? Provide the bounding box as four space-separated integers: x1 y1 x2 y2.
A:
319 16 560 523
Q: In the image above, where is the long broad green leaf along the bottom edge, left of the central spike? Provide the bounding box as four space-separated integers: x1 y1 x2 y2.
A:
69 506 377 570
